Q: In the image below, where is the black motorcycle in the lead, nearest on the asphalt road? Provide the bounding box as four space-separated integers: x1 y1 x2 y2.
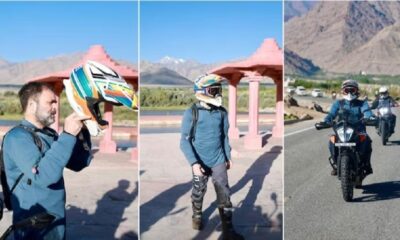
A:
315 114 376 202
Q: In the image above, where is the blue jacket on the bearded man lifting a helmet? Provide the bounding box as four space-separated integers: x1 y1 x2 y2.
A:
3 120 93 240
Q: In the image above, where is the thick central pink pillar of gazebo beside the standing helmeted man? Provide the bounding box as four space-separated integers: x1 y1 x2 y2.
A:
244 77 262 149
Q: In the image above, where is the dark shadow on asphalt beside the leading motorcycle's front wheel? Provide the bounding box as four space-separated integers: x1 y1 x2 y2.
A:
353 181 400 202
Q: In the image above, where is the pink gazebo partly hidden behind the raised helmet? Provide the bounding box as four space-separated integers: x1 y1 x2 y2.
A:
29 45 138 159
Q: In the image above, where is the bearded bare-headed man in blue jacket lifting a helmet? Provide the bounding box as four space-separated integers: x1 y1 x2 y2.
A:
3 82 92 240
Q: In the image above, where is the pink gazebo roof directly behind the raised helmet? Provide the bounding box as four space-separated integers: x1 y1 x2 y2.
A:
28 45 138 90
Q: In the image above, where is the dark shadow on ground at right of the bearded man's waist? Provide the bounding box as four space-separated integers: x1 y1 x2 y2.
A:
67 180 138 240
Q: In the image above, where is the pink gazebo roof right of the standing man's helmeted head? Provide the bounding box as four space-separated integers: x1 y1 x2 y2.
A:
210 38 283 80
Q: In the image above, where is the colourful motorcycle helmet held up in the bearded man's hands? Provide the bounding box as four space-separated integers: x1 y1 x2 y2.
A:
63 61 138 136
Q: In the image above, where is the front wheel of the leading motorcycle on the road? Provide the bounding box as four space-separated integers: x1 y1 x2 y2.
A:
340 155 353 202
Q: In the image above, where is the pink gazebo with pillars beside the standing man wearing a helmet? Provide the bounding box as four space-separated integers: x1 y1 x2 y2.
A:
211 39 283 149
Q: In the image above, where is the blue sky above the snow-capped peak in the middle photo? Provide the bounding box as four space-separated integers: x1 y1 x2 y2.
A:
140 1 282 63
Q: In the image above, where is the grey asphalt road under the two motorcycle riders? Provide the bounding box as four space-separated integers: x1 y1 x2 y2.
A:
284 110 400 240
